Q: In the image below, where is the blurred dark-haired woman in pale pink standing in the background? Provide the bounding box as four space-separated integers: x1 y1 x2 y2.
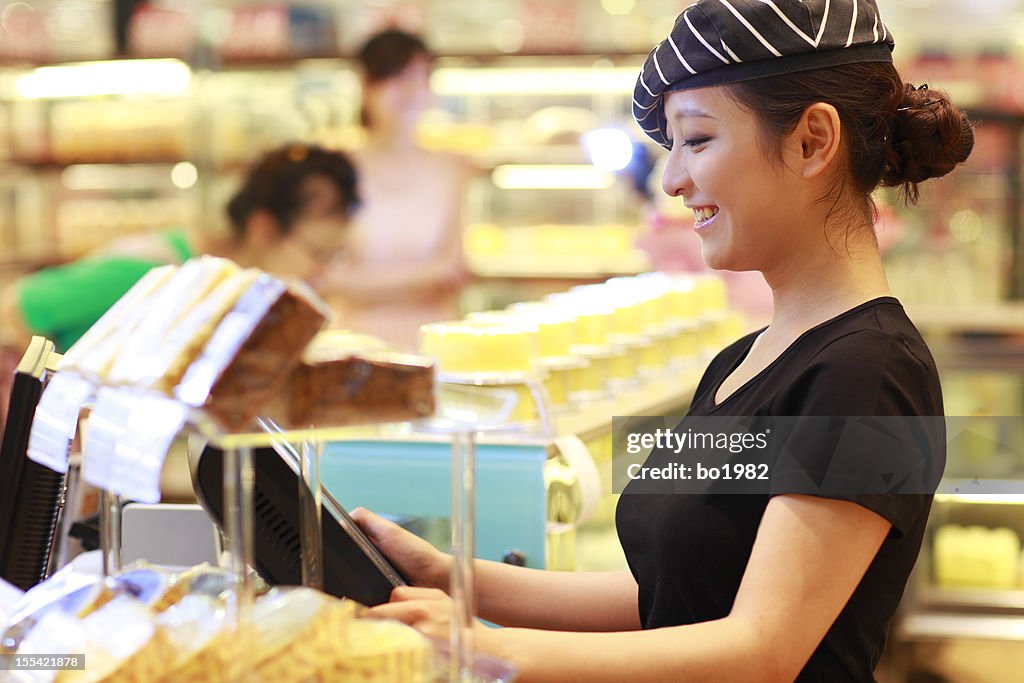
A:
324 30 472 349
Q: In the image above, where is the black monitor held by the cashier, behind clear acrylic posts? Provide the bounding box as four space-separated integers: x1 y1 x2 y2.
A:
193 446 406 605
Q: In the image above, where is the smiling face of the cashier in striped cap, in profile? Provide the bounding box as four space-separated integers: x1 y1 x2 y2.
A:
662 87 802 271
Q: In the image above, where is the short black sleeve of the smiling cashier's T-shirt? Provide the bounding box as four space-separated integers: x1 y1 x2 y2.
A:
770 330 945 536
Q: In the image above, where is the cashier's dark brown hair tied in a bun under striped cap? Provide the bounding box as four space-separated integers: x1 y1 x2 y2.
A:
729 61 974 215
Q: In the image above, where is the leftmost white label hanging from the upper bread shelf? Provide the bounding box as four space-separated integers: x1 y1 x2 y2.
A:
28 373 93 473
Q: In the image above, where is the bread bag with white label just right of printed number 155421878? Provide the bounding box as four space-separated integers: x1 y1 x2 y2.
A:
56 595 174 683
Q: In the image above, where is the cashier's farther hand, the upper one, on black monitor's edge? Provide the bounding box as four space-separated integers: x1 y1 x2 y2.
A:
351 508 452 599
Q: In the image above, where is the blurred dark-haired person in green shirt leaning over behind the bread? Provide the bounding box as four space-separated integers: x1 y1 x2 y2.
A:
0 144 358 353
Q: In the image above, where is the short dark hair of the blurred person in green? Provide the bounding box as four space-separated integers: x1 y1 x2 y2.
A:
227 143 359 234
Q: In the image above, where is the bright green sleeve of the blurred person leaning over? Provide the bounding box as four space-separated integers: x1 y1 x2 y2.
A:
18 258 159 351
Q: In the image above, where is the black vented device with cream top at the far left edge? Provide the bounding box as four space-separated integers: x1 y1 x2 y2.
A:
0 337 65 591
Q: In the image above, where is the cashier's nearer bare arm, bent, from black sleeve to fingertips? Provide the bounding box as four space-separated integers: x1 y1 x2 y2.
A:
373 496 890 683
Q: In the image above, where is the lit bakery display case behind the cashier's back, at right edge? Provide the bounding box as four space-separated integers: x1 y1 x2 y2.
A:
890 337 1024 680
